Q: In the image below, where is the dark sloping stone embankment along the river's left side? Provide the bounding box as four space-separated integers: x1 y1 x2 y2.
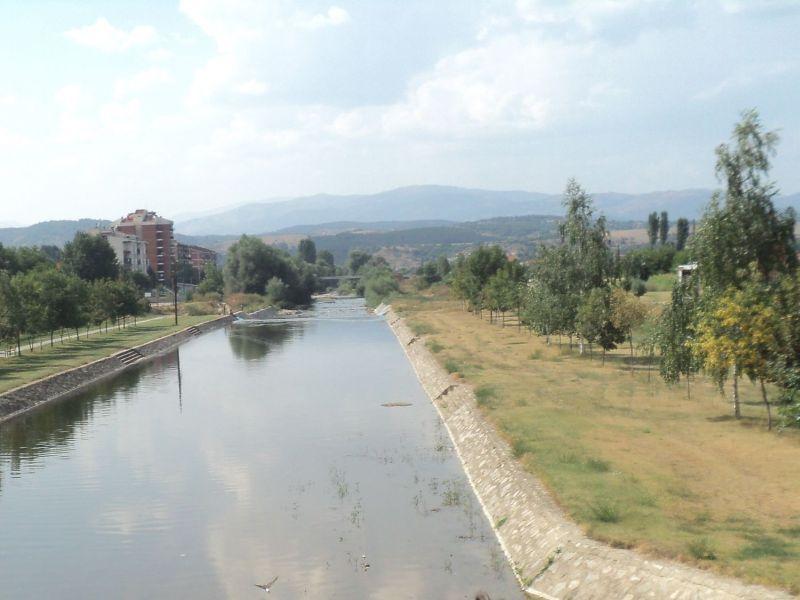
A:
0 316 233 423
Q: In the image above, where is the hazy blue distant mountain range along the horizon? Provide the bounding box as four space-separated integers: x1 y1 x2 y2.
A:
0 185 800 246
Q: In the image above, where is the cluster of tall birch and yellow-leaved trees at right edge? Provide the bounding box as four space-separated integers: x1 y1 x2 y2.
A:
659 111 800 428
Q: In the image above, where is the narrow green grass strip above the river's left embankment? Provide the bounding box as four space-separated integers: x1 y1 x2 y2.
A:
0 315 217 393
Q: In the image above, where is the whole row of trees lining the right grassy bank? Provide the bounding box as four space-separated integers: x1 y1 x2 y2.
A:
446 111 800 428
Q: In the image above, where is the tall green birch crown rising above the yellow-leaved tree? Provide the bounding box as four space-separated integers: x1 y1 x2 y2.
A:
691 110 797 294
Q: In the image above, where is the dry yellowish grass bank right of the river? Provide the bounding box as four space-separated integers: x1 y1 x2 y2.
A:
394 289 800 592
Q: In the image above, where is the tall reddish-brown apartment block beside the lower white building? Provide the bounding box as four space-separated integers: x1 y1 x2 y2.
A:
111 209 176 285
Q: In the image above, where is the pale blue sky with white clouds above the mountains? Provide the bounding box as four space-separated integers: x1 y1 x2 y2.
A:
0 0 800 223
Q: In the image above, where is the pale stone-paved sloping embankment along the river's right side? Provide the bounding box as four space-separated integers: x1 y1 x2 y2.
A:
386 311 793 600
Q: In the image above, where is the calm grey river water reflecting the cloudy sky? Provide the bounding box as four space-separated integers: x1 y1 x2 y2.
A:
0 300 522 600
